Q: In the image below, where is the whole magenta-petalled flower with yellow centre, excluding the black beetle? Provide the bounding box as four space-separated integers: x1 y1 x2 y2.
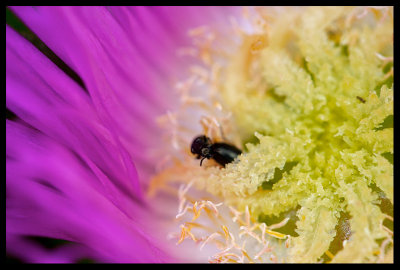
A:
6 7 393 262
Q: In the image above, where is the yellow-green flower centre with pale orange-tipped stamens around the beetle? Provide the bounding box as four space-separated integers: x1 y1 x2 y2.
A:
149 7 393 262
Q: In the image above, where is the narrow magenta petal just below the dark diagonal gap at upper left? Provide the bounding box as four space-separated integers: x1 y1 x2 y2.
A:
6 25 140 196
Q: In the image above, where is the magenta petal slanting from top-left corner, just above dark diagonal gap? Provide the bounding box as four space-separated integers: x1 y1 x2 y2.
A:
9 7 188 185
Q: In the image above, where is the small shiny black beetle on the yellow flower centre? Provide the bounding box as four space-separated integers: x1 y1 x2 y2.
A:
191 135 242 167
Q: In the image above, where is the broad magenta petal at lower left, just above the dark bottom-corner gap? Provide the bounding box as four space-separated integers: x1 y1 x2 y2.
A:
6 121 172 262
